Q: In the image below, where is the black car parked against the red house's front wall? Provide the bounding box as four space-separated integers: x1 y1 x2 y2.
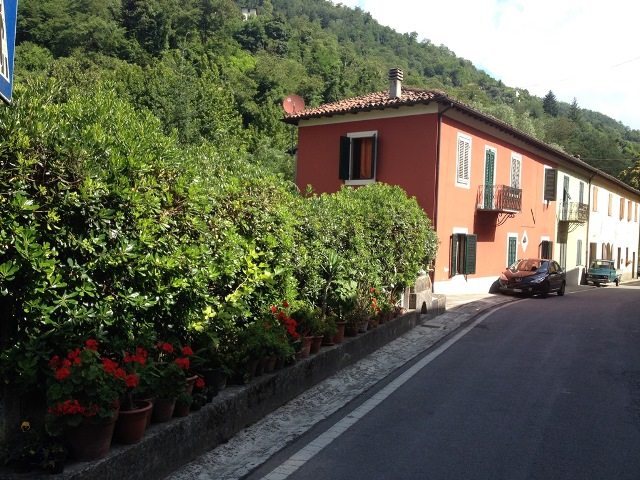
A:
498 258 567 297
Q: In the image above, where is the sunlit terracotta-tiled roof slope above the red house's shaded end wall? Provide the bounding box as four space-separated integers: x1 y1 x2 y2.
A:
284 87 449 124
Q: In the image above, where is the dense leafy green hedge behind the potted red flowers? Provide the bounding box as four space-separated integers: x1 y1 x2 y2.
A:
0 80 436 389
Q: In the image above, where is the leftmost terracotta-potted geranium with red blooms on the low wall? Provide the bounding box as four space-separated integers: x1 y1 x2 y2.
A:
46 339 127 460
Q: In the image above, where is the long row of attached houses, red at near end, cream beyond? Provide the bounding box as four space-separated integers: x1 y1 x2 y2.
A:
285 69 640 293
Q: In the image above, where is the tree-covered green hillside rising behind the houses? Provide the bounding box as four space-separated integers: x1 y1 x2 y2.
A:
16 0 640 187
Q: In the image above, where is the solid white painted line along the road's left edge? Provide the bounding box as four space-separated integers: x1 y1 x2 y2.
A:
262 302 511 480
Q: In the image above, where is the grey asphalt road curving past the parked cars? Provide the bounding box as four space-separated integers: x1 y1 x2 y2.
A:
247 287 640 480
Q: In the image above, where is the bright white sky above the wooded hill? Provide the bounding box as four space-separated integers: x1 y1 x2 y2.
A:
334 0 640 130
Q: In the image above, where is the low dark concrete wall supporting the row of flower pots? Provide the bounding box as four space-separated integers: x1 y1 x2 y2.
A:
0 297 445 480
